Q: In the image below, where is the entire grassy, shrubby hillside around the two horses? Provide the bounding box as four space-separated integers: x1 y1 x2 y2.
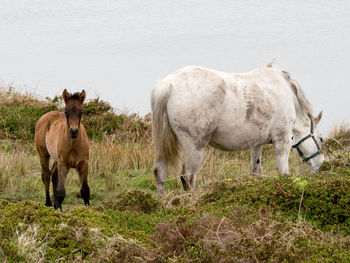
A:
0 90 350 263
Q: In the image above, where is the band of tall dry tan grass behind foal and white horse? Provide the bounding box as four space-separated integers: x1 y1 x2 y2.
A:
0 136 308 200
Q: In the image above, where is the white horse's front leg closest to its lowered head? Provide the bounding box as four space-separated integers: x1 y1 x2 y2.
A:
272 131 291 174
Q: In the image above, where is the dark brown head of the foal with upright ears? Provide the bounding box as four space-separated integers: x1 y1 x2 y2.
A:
62 89 86 139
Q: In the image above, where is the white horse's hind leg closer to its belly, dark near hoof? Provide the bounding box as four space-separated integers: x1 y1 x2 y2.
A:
181 143 205 191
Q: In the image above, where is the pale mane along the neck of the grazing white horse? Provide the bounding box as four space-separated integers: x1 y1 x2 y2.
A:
282 70 313 119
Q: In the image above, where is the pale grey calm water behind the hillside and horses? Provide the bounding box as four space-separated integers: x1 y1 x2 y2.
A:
0 0 350 131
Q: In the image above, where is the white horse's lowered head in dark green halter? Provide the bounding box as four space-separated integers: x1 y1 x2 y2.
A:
292 111 324 173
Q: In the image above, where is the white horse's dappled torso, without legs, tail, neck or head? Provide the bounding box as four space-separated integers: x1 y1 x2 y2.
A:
167 66 295 150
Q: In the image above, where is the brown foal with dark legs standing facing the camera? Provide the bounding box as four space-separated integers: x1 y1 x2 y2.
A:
35 90 90 211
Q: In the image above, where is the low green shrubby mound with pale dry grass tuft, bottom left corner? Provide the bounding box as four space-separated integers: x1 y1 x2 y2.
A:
0 201 151 262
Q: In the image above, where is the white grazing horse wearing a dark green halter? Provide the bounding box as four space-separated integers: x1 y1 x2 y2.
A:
151 62 324 193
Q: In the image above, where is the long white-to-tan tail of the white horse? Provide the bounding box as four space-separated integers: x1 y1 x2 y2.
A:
151 80 179 165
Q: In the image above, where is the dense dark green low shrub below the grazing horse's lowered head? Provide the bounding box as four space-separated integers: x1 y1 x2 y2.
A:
201 175 350 234
